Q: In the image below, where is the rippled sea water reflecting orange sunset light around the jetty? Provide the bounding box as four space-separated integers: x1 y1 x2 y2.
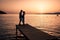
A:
0 14 60 40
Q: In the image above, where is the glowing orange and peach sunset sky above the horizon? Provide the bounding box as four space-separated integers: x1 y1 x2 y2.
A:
0 0 60 13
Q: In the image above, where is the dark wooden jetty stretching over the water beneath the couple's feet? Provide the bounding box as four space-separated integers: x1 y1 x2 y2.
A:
16 24 54 40
